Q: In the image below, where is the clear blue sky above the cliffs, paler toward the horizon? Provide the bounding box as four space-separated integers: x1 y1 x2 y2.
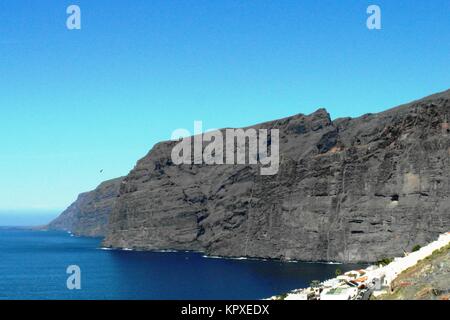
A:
0 0 450 210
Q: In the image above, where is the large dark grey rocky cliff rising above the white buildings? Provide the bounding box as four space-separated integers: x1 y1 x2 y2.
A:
104 90 450 262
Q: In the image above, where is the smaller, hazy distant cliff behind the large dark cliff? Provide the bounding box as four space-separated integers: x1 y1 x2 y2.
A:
46 178 123 237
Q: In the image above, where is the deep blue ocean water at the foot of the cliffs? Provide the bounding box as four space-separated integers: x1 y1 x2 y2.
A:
0 229 358 299
